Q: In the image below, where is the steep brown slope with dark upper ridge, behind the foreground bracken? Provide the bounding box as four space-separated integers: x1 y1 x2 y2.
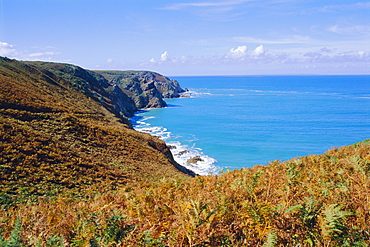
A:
0 58 191 205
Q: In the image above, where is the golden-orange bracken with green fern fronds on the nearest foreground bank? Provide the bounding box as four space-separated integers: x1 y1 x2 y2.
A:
0 140 370 247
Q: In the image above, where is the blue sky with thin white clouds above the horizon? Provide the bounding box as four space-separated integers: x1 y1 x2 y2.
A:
0 0 370 76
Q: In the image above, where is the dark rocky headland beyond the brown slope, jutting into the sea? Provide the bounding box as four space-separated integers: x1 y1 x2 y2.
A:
27 62 184 123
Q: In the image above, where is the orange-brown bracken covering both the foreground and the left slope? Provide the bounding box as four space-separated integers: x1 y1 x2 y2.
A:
0 59 370 247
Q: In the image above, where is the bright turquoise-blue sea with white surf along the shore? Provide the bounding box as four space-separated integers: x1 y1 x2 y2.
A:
131 75 370 175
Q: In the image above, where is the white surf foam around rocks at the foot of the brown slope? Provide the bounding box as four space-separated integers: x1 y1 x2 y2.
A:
131 112 221 175
